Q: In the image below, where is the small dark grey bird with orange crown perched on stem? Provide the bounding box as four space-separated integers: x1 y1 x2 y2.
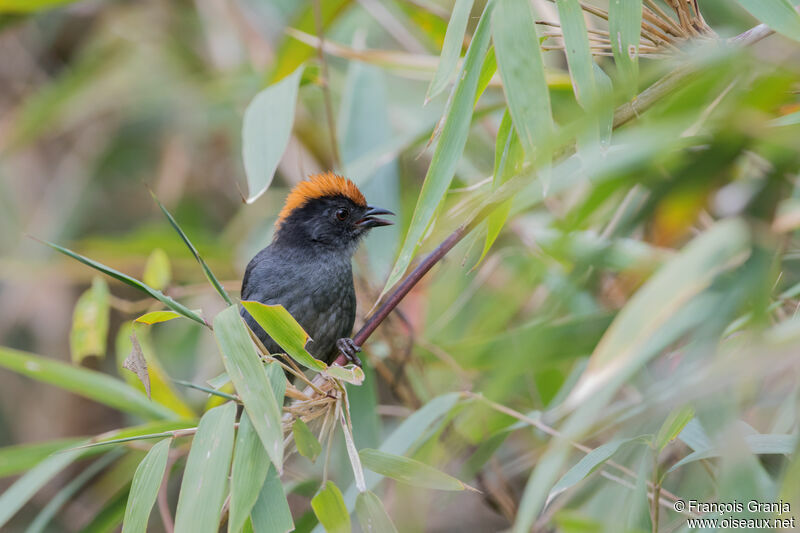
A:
241 172 394 365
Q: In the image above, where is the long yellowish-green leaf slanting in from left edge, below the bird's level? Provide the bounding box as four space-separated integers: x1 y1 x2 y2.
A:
0 346 180 419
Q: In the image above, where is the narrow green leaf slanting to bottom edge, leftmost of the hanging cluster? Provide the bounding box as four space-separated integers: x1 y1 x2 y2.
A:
122 439 172 533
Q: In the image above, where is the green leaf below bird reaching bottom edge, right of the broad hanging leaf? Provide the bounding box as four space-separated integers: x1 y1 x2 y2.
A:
228 413 270 533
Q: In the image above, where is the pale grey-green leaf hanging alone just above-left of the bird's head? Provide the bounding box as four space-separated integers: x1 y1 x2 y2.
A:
242 65 304 203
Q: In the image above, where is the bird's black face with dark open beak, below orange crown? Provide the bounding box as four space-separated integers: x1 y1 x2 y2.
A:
279 196 394 253
